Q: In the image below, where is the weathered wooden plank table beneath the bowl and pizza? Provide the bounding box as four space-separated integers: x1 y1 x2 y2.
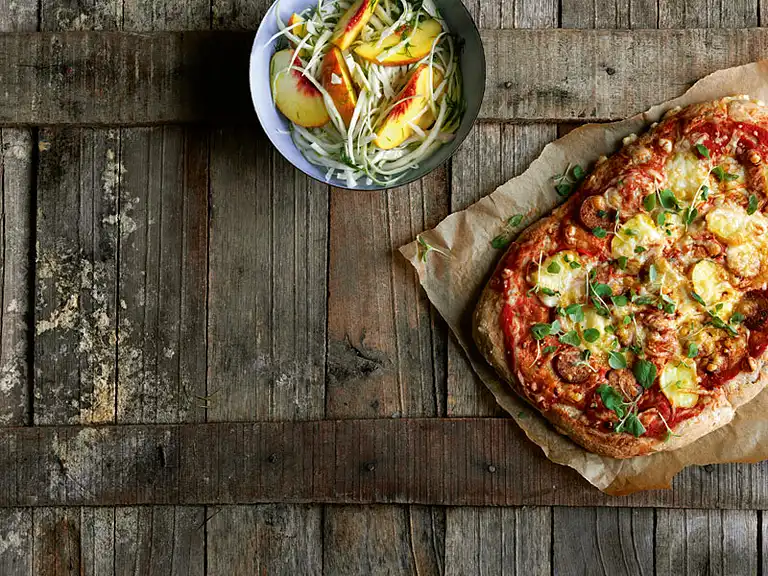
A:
0 0 768 576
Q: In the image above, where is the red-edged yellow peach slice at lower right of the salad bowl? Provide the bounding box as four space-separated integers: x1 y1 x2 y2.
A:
374 64 442 150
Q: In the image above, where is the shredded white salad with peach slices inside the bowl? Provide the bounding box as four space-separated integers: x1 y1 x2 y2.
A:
269 0 464 187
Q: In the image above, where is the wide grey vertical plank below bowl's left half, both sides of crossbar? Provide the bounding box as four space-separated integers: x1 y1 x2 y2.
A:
206 128 328 576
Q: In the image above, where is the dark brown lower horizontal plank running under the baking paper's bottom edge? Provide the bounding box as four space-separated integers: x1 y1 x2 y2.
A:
0 418 768 509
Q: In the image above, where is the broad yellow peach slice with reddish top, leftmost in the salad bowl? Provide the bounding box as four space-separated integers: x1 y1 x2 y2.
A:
270 48 331 128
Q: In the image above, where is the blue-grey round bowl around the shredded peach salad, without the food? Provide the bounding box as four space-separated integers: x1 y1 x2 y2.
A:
250 0 485 190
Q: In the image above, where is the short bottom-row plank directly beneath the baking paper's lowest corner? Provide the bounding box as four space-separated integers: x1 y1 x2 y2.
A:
552 508 656 576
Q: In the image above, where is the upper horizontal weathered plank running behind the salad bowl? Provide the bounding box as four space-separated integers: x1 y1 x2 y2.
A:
0 29 768 125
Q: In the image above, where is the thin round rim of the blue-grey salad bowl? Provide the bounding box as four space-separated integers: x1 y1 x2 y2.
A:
248 0 488 192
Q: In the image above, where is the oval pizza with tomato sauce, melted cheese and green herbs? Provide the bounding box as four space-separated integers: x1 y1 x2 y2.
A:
474 97 768 458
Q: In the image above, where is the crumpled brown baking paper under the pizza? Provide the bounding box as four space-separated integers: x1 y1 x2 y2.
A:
400 60 768 494
